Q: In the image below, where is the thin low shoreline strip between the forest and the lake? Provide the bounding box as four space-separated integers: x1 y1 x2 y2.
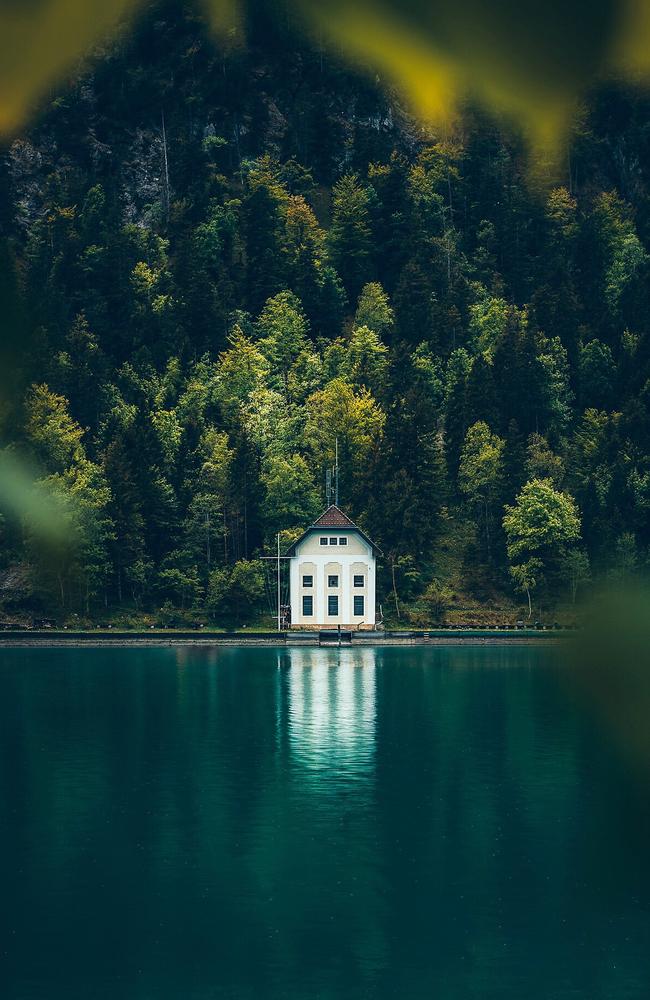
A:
0 629 572 650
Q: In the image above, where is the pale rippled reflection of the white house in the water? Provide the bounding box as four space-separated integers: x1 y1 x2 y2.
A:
287 648 377 783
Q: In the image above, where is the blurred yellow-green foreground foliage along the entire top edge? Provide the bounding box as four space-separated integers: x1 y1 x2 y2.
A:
0 0 650 145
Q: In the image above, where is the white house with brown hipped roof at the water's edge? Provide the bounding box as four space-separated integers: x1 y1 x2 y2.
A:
287 504 381 629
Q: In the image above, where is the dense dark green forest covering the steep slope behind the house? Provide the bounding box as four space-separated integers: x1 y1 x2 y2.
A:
0 0 650 624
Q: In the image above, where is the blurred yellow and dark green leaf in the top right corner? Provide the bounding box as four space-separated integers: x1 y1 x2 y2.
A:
296 0 650 148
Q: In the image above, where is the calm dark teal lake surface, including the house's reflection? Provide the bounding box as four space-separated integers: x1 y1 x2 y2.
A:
0 648 650 1000
